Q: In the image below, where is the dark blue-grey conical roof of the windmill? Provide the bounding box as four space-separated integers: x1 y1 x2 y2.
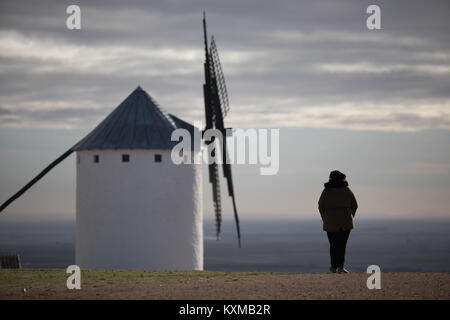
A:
72 87 195 151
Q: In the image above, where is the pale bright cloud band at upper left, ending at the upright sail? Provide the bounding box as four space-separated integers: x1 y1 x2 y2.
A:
0 32 202 76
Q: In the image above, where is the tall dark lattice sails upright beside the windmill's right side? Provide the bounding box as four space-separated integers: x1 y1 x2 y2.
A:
203 14 241 247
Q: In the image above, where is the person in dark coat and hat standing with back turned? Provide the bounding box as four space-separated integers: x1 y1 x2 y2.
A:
319 170 358 273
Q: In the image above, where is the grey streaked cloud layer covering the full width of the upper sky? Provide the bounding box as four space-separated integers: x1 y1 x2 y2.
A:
0 1 450 131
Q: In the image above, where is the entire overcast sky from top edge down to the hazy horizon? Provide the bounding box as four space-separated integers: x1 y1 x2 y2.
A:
0 0 450 222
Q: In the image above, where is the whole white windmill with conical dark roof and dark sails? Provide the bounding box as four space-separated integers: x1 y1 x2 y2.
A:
0 12 241 270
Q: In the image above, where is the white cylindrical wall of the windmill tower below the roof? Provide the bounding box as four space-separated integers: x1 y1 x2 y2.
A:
76 150 203 270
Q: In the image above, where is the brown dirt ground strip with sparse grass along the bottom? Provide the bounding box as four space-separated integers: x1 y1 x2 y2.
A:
0 270 450 300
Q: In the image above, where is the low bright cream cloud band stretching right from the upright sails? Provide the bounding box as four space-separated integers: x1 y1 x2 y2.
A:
230 100 450 131
